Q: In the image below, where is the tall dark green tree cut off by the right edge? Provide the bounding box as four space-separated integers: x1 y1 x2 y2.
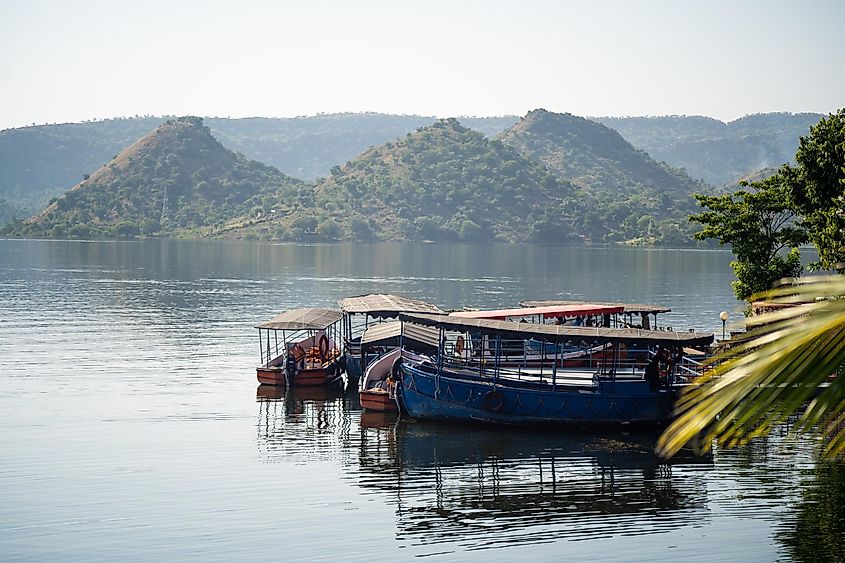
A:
781 108 845 270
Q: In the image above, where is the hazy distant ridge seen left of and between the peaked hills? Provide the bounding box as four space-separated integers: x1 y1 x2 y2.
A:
0 113 517 225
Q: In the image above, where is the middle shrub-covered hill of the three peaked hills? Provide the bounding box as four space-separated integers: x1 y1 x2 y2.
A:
238 119 579 242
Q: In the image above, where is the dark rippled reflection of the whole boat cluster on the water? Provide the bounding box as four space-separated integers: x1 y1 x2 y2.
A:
258 389 713 553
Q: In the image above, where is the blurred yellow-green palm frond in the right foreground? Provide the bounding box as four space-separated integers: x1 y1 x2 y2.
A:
657 276 845 457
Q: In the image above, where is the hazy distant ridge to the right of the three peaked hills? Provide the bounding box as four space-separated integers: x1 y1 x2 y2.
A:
594 113 823 186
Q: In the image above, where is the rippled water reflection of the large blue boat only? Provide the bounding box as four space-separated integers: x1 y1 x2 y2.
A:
360 423 711 549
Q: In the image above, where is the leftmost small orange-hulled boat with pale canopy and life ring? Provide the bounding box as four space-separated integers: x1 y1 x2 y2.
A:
255 308 343 386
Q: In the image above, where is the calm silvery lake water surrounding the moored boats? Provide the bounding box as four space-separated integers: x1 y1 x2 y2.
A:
0 240 842 561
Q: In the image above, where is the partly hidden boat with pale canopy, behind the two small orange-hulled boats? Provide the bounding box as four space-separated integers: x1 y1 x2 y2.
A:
339 293 443 383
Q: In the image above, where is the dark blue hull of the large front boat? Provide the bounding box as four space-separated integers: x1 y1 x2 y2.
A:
397 364 675 426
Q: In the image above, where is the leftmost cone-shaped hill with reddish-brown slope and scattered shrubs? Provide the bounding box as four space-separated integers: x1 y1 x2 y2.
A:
6 117 310 238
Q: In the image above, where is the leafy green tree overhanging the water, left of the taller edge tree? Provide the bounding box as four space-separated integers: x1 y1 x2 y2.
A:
689 176 807 300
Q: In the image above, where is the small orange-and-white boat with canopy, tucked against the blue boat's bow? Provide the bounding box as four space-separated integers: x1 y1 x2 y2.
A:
358 321 437 412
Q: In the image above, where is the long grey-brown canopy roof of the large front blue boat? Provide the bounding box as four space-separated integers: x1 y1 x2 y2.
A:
399 313 713 348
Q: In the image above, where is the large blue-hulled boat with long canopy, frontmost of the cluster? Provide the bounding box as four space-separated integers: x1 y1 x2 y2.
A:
396 314 713 426
